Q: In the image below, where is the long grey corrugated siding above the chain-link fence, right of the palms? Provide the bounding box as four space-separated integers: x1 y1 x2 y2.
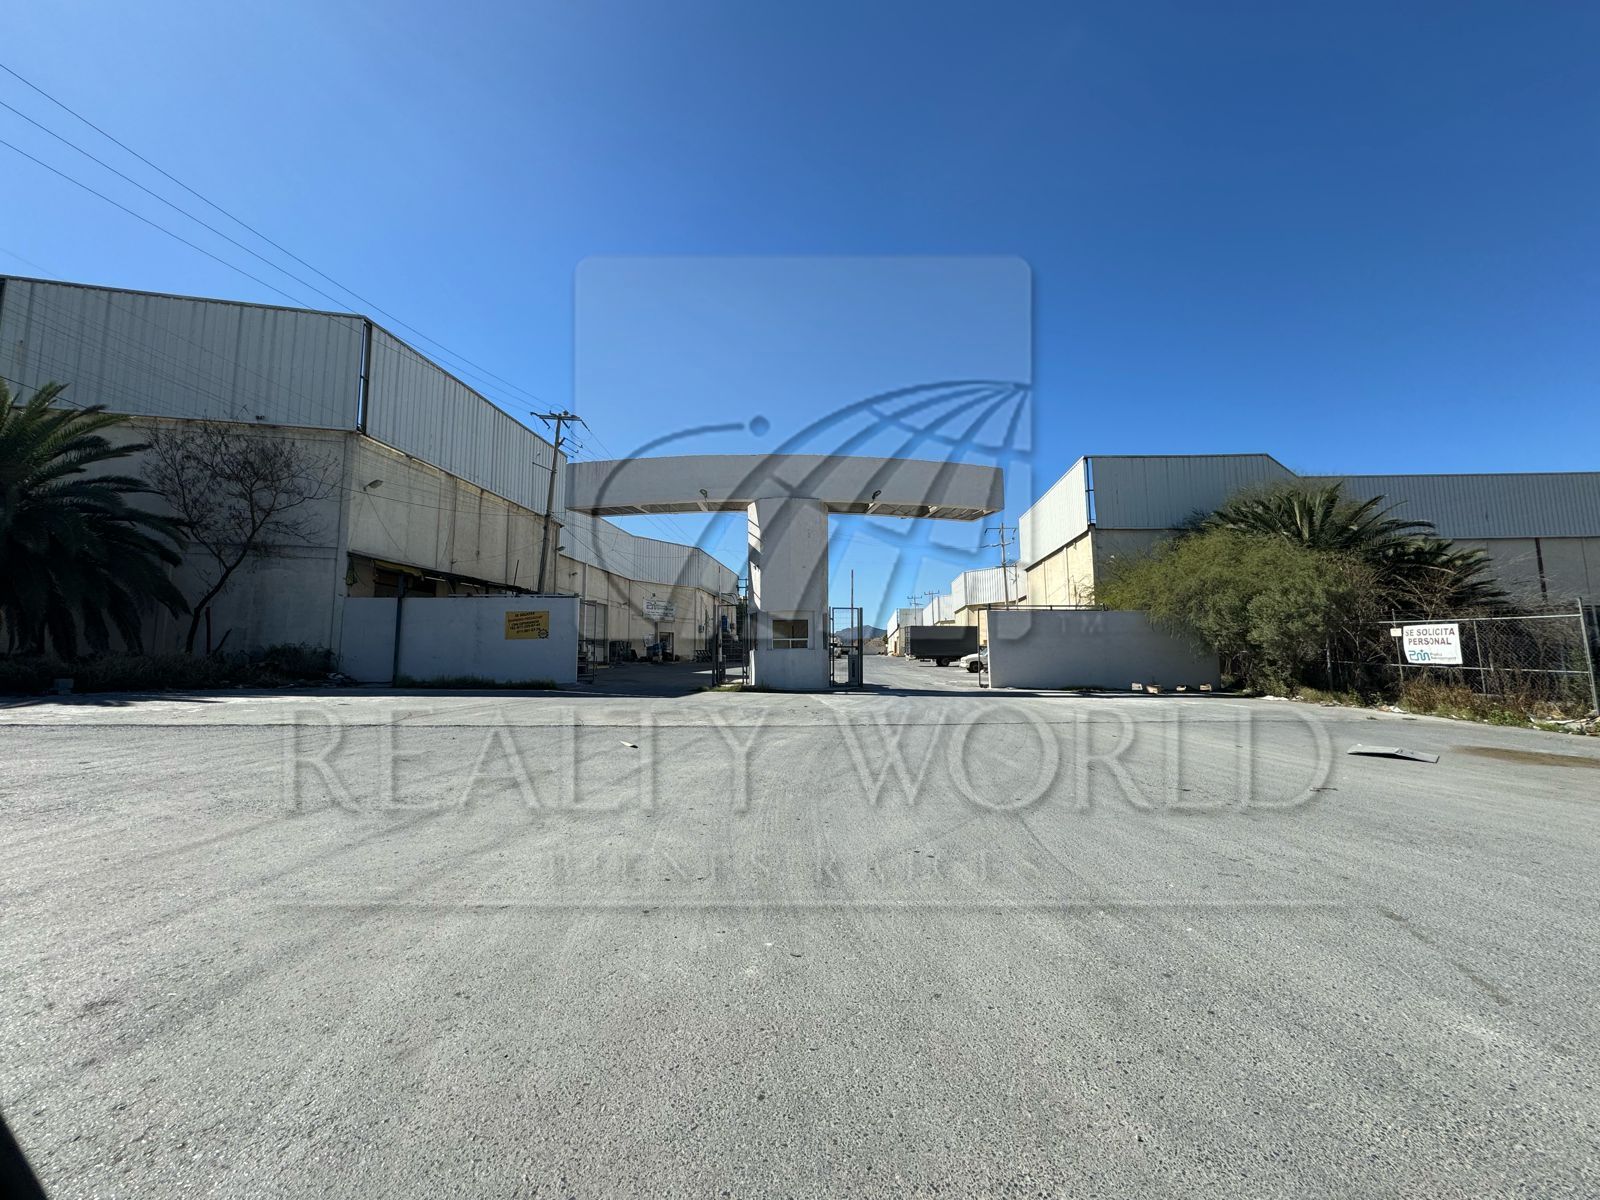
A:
1318 472 1600 538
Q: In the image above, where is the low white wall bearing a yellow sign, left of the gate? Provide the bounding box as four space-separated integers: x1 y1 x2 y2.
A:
341 595 578 683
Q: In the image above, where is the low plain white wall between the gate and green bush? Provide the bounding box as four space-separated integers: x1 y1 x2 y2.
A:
989 608 1222 690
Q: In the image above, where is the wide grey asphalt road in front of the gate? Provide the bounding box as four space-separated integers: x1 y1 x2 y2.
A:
0 659 1600 1197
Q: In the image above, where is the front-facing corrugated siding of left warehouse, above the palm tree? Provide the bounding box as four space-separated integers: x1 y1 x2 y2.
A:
0 278 362 429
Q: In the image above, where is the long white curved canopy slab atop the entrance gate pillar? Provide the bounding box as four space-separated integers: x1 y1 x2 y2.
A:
566 454 1005 520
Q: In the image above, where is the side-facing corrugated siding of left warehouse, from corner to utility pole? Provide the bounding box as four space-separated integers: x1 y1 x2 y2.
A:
366 326 566 514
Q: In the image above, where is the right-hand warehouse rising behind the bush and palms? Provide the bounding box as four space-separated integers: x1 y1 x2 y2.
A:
1018 454 1600 605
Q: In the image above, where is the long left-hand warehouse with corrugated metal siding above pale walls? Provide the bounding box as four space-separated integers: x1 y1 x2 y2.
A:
0 277 738 661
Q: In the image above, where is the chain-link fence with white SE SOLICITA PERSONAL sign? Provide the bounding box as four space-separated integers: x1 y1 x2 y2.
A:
1328 603 1600 712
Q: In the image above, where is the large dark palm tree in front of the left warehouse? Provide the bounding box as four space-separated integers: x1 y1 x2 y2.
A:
0 381 189 658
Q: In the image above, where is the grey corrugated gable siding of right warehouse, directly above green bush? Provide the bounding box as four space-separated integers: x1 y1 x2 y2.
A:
1088 454 1294 530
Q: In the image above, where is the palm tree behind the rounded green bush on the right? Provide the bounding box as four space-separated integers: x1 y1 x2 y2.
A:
1197 483 1506 611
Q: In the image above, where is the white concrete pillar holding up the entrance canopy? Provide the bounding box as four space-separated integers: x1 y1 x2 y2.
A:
749 499 829 691
